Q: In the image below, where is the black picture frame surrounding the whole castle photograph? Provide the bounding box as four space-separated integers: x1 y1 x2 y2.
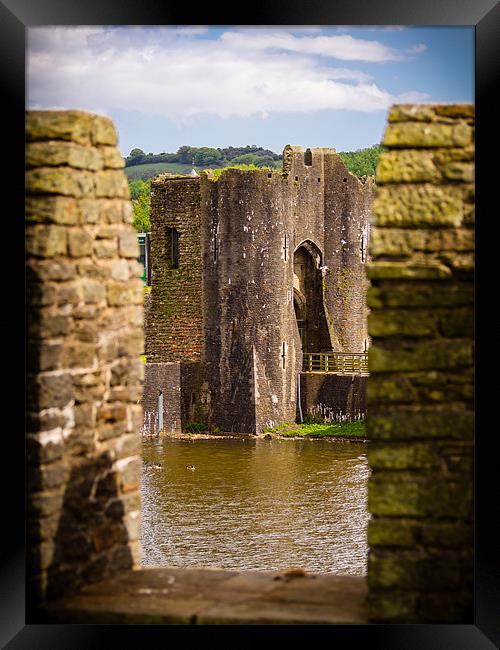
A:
8 0 500 650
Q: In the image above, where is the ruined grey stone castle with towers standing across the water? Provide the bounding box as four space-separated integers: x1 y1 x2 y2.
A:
143 145 374 433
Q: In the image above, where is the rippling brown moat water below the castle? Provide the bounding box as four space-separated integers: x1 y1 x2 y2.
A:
141 438 370 575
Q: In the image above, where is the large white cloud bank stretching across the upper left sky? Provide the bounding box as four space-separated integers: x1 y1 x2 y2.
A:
28 27 426 123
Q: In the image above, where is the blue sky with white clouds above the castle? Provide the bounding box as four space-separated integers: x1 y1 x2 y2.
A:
26 26 474 156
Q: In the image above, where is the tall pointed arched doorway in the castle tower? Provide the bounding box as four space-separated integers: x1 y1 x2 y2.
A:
293 241 332 352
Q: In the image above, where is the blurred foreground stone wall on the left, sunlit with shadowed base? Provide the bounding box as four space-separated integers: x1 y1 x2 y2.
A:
26 111 144 605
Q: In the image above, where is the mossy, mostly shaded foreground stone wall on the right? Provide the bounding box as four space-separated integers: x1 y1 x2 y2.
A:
368 105 474 623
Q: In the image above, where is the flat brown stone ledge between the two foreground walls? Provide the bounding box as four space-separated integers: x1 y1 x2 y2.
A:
41 567 367 625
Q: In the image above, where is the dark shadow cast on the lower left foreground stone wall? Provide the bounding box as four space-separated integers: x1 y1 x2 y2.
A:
28 451 134 612
